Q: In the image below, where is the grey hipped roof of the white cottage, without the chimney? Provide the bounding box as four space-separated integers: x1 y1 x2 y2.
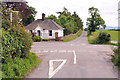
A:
26 19 64 30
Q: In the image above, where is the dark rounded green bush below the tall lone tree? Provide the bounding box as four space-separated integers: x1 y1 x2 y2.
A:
91 32 111 44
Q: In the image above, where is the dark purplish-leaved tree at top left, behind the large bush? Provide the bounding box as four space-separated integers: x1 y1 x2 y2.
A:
2 1 37 26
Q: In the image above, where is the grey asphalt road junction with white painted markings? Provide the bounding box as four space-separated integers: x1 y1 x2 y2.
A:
27 32 118 78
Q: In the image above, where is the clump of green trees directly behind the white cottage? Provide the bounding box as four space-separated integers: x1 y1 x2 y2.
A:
46 8 83 35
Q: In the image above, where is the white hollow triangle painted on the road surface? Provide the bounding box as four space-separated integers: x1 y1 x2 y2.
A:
48 59 67 78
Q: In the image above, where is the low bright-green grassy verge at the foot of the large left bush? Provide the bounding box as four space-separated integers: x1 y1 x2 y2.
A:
2 53 41 78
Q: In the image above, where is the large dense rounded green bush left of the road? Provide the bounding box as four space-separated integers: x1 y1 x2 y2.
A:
2 25 32 63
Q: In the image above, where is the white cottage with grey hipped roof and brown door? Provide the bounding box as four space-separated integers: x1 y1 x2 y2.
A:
26 14 64 39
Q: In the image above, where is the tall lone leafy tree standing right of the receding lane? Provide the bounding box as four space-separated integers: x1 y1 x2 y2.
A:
87 7 106 34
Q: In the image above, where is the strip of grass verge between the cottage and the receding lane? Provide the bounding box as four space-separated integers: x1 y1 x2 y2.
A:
63 30 83 42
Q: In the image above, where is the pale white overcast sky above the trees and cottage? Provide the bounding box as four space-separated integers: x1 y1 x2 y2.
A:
26 0 120 27
